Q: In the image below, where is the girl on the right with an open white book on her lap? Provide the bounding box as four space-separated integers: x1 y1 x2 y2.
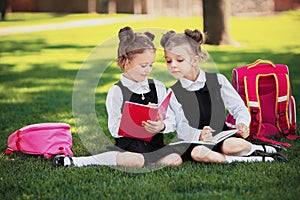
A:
161 29 286 163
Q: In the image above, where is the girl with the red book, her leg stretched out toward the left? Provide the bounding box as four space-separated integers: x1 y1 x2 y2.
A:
54 27 182 167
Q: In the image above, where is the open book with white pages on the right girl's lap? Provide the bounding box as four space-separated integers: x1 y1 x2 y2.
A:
169 129 239 145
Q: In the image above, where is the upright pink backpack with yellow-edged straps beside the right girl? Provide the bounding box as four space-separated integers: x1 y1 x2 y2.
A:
226 59 300 147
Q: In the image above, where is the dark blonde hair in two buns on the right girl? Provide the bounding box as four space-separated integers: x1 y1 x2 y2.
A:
160 29 207 59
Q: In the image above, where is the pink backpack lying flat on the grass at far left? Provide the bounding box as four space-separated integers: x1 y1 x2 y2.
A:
5 123 73 158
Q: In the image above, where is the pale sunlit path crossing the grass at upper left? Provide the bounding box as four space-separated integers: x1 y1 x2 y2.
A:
0 15 153 35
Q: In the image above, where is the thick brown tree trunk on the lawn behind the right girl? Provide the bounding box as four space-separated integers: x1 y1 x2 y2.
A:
202 0 233 45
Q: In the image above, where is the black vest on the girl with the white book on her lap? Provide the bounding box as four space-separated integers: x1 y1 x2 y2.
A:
171 73 227 132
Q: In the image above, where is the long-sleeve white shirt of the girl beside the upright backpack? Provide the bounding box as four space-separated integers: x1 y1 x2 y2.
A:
170 69 251 141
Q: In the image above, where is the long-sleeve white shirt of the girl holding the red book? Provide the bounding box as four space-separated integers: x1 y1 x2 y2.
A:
106 74 175 138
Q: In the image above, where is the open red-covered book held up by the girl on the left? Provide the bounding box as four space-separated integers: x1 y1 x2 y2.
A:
118 91 172 142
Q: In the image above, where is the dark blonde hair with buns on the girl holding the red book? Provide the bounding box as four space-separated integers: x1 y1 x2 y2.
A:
118 26 155 70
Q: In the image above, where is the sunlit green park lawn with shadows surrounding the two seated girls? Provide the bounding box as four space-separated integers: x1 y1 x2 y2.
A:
0 1 300 199
